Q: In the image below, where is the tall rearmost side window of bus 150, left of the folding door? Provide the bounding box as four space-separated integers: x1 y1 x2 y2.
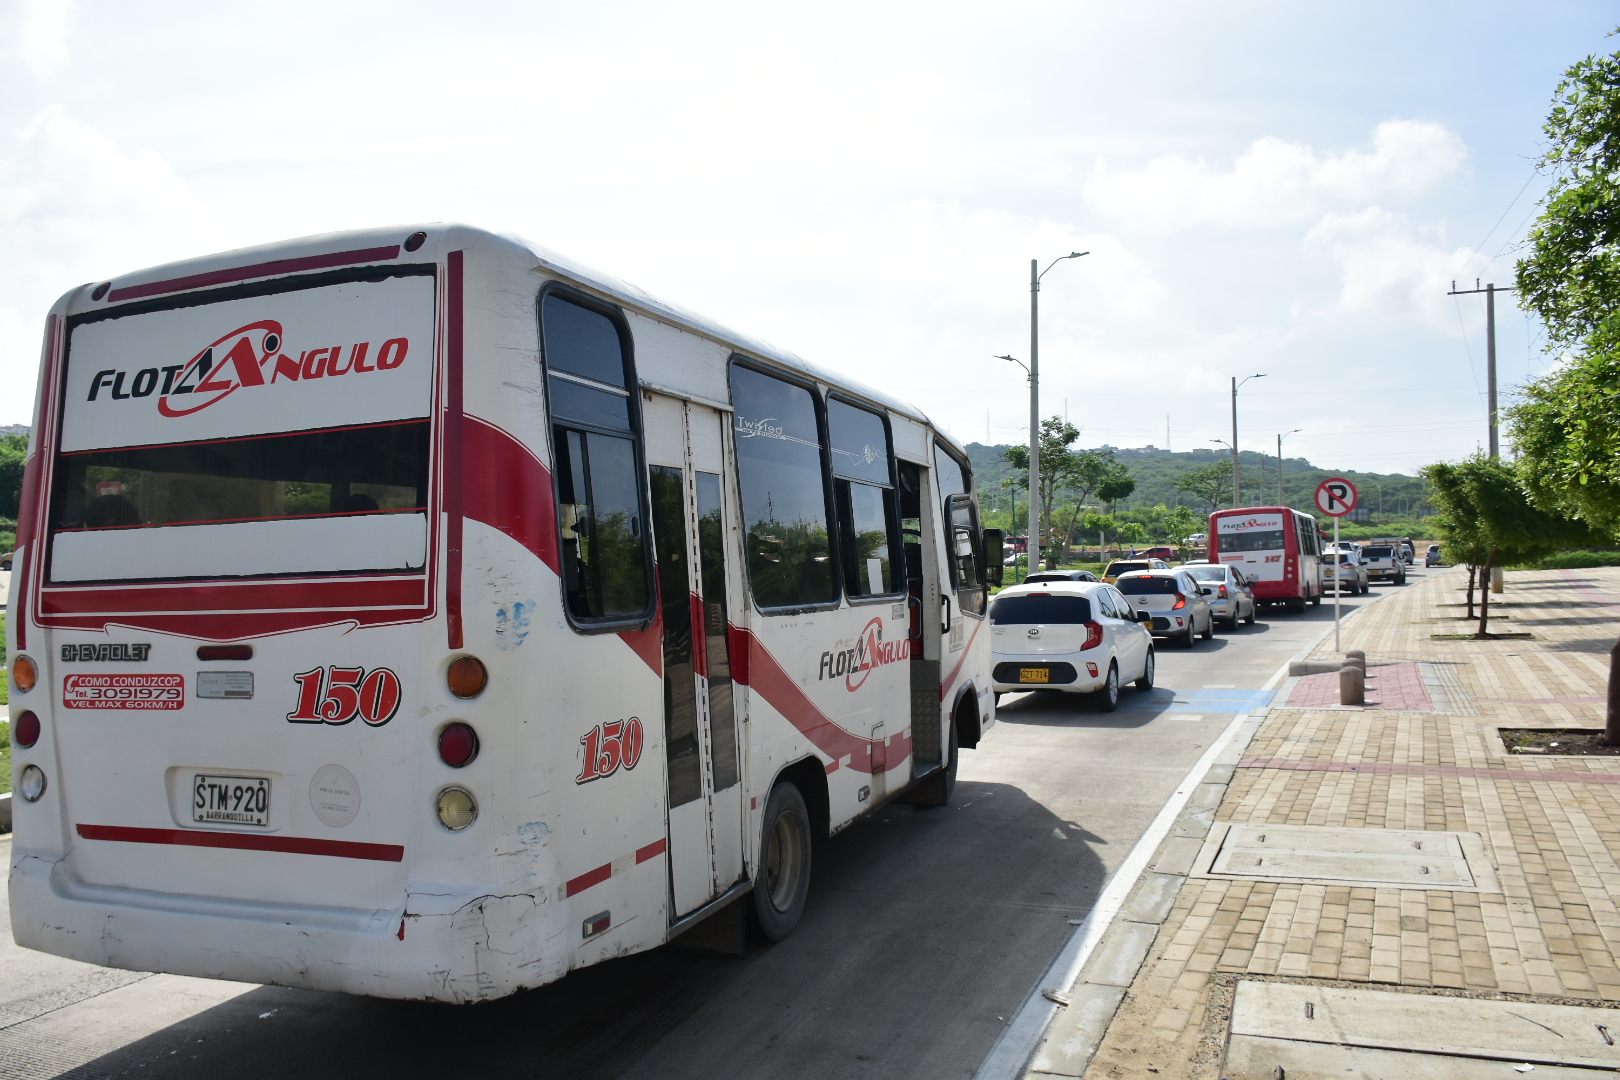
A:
539 293 653 623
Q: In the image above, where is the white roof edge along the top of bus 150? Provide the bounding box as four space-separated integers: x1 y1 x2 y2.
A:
66 222 967 458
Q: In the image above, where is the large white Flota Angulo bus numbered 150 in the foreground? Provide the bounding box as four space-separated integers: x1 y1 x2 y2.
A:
6 225 1001 1002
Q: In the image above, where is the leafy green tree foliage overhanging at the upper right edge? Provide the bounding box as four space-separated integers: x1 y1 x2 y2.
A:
1508 34 1620 534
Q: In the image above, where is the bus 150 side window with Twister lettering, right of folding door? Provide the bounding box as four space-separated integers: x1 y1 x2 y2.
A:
731 363 838 609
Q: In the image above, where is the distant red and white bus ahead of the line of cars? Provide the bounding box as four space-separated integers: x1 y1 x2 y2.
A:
1210 507 1322 612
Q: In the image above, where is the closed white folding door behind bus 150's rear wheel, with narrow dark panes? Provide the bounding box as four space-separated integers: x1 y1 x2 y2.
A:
643 393 744 918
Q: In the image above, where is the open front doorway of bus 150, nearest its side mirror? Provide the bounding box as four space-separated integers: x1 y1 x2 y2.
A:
899 461 944 774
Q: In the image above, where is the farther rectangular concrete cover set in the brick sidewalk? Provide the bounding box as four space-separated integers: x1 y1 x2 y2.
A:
1194 824 1499 892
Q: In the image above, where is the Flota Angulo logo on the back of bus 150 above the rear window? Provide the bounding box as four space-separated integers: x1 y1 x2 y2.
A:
86 319 410 416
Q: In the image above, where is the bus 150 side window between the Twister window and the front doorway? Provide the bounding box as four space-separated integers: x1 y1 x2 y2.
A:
826 398 901 597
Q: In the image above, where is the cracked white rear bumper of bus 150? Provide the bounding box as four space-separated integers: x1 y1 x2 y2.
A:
10 852 570 1004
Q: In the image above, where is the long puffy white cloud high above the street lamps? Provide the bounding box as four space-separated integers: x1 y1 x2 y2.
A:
1085 120 1468 230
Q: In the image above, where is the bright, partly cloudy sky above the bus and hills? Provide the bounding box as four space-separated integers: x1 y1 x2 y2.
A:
0 0 1620 473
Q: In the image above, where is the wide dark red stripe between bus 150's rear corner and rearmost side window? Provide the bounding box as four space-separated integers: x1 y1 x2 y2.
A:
460 416 562 573
